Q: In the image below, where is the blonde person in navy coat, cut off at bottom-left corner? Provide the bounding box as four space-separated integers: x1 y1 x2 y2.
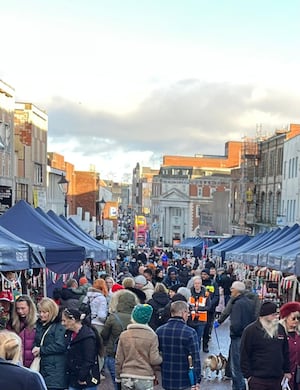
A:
0 330 47 390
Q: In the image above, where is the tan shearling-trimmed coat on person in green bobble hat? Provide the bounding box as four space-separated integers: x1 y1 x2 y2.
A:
116 324 162 380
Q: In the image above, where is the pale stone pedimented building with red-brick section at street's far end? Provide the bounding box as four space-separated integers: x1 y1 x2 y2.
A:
151 167 230 246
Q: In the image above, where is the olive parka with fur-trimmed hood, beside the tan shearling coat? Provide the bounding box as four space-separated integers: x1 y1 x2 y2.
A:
101 291 136 357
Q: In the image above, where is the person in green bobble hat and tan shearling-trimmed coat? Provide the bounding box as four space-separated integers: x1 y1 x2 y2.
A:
116 304 162 390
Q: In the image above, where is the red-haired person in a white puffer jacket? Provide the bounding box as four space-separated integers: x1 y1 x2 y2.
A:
83 279 108 335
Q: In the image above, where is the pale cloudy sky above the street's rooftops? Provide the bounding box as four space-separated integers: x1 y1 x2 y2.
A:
0 0 300 181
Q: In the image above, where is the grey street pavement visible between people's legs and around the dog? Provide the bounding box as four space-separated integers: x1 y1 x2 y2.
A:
99 320 231 390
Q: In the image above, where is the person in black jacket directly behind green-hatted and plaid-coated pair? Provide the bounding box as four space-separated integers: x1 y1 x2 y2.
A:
147 283 170 330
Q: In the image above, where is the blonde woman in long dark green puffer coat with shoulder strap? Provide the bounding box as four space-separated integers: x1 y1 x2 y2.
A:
32 298 67 390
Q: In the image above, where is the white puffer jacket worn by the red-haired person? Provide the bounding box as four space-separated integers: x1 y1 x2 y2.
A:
83 287 108 325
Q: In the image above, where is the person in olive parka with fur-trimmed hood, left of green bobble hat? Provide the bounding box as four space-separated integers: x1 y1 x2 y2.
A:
101 289 138 389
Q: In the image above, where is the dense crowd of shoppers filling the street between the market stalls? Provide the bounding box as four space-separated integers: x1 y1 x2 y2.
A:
0 252 300 390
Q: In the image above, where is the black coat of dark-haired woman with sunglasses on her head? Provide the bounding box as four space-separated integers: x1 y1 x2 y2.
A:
67 325 100 389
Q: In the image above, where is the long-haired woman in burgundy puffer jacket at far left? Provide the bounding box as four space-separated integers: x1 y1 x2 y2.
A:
7 295 37 367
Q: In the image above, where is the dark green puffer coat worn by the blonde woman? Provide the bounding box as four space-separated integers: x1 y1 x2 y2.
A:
34 318 67 389
